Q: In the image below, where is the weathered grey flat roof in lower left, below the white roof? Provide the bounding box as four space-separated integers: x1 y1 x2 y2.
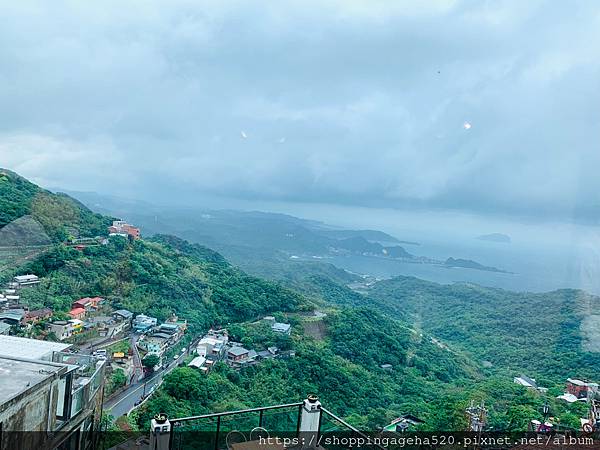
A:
0 356 66 405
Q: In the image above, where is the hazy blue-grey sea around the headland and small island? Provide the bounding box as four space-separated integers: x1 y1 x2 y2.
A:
260 204 600 295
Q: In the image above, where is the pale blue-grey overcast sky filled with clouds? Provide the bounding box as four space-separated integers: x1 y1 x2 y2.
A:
0 0 600 221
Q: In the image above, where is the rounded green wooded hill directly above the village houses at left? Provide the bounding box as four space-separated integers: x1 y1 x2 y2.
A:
17 237 303 330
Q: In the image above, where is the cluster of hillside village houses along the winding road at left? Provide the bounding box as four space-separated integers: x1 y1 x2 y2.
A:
0 220 294 414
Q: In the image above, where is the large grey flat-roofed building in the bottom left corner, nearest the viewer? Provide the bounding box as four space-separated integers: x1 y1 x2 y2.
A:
0 336 104 449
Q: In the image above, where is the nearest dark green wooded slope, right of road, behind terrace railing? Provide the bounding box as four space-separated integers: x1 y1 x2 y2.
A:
134 308 585 430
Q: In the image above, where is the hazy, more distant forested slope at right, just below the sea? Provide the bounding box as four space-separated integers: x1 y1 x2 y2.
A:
369 277 600 386
